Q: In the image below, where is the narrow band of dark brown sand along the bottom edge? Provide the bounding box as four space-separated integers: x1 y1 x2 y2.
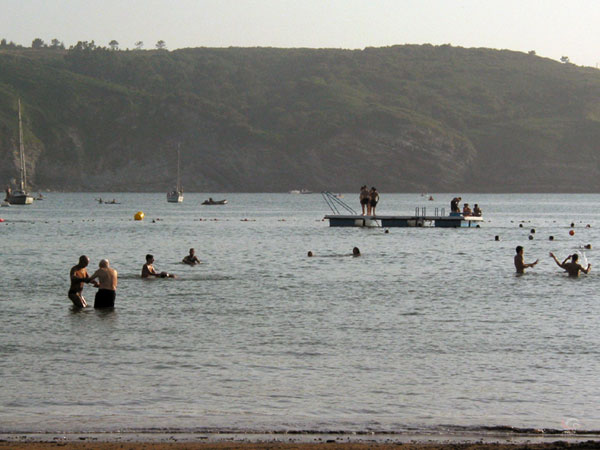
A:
0 440 600 450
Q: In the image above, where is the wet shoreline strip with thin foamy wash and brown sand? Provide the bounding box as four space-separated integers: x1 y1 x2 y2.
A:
0 433 600 450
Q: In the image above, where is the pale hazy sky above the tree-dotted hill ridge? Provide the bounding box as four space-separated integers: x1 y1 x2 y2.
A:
0 0 600 67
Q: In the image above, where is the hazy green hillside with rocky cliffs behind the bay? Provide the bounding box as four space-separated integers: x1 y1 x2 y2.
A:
0 46 600 192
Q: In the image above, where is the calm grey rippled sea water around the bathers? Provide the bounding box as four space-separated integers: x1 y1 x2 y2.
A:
0 193 600 432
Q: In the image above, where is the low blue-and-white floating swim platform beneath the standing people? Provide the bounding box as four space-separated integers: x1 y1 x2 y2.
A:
325 214 483 228
